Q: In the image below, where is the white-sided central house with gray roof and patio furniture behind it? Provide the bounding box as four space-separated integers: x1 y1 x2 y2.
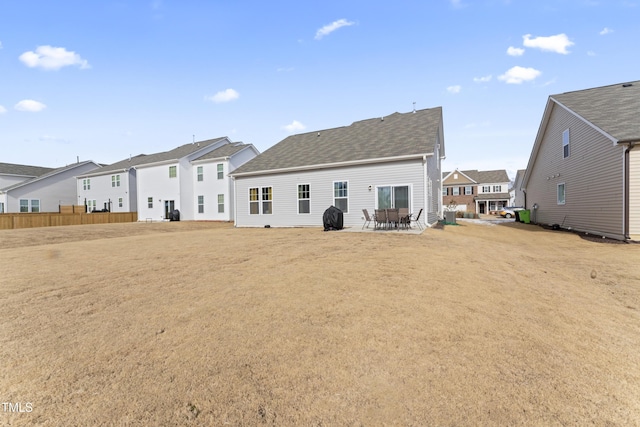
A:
231 107 444 227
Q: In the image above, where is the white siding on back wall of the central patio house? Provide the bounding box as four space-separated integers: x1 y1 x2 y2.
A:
235 159 428 227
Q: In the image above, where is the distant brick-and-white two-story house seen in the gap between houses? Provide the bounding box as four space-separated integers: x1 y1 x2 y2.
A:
442 169 510 214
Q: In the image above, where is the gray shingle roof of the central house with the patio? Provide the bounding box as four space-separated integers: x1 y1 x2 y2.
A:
231 107 442 175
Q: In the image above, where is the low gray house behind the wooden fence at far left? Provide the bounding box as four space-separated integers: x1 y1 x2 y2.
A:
0 161 100 213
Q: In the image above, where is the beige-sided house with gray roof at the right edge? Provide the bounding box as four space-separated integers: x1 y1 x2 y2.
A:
521 81 640 240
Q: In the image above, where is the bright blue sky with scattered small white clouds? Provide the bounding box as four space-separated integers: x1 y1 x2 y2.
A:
0 0 640 178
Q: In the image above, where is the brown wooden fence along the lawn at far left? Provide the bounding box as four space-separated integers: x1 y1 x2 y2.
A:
0 212 138 230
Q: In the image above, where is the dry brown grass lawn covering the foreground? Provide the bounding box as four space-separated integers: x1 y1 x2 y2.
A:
0 222 640 426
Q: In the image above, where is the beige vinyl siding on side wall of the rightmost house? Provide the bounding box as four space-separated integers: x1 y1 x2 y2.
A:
526 105 624 238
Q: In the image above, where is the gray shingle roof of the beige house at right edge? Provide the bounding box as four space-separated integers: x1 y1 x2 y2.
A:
551 81 640 142
